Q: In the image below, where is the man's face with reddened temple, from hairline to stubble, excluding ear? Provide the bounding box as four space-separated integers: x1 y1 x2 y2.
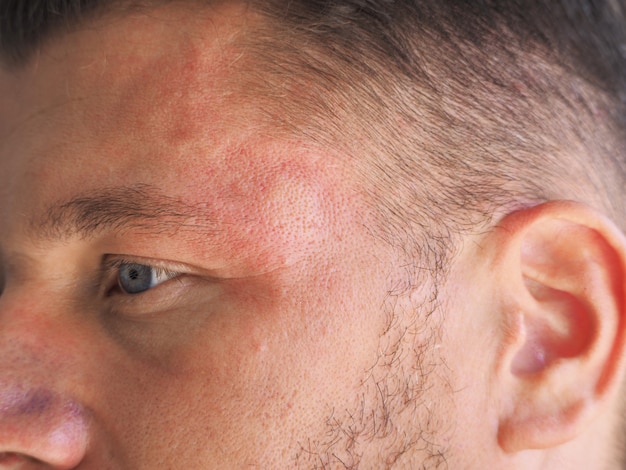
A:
0 2 460 469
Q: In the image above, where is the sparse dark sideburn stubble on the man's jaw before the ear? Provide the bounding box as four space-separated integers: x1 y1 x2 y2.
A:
294 293 454 470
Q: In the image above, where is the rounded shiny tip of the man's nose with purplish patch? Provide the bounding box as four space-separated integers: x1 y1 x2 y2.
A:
0 384 88 470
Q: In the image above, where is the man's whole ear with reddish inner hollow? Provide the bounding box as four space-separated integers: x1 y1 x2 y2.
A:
491 202 626 452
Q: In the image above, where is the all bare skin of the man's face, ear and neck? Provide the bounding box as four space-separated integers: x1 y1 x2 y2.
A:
0 2 626 470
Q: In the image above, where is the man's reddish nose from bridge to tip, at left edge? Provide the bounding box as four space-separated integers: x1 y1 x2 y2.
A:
0 291 89 469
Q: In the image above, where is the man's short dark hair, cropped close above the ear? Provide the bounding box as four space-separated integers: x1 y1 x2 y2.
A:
0 0 626 464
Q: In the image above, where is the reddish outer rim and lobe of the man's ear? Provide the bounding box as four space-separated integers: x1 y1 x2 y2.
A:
492 201 626 453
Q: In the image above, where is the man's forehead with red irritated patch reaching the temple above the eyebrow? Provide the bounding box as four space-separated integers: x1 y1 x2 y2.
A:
0 6 360 272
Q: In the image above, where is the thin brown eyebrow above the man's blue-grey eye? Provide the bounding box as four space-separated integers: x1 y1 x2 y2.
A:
31 184 217 239
